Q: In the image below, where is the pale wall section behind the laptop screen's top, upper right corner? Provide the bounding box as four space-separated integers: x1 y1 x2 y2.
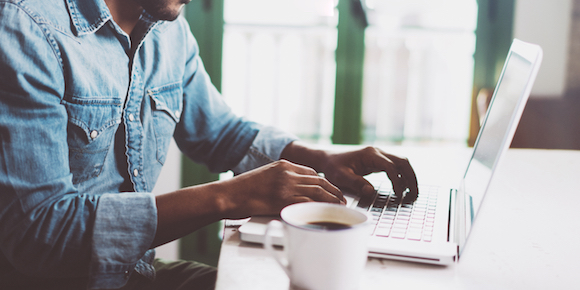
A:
513 0 573 97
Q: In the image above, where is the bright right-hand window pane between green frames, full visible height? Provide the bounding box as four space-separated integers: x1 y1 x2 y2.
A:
363 0 477 143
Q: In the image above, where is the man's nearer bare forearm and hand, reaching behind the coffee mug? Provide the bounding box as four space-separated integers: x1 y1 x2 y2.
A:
151 160 346 248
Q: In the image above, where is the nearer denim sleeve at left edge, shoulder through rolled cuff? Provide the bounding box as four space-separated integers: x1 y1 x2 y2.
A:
0 2 157 288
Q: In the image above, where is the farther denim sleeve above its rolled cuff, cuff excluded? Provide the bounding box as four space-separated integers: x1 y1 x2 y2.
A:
174 19 254 172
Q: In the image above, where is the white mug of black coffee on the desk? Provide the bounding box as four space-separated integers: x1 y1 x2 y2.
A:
264 202 370 290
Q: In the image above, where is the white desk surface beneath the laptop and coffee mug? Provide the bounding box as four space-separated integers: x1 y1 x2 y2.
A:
216 147 580 290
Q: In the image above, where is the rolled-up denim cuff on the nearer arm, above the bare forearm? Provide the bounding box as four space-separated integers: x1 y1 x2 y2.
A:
89 193 157 289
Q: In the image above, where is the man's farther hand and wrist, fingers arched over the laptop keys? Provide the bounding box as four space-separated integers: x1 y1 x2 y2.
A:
282 142 418 201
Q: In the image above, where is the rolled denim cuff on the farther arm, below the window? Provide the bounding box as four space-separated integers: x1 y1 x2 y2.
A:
232 126 298 174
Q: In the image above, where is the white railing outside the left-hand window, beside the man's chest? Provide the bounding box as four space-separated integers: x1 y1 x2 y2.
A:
222 24 336 141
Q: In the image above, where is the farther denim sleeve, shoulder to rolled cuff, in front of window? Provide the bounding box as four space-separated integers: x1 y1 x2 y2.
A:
174 21 298 173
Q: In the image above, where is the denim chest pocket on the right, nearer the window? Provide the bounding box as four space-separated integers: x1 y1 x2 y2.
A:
147 82 183 164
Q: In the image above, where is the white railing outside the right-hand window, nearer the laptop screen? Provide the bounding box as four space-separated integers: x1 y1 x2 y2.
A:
363 27 475 143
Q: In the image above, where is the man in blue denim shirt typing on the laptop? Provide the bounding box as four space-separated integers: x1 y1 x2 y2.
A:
0 0 417 289
